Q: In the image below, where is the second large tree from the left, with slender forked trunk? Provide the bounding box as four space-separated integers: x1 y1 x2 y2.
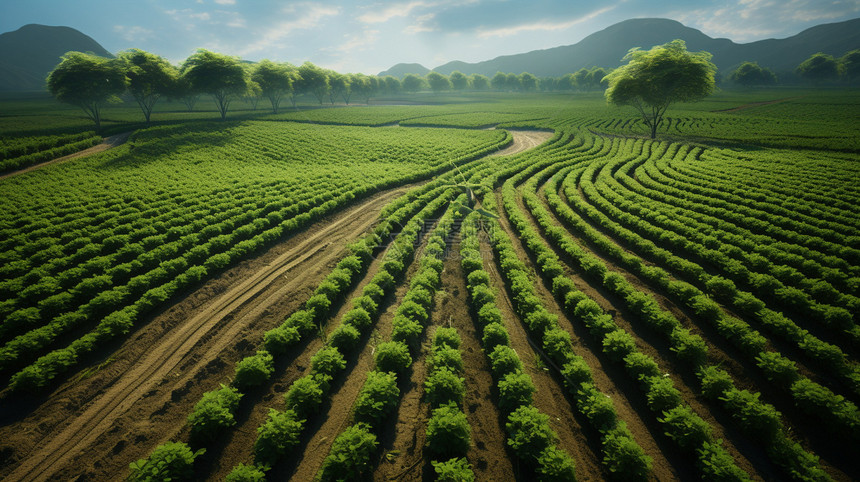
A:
117 49 179 124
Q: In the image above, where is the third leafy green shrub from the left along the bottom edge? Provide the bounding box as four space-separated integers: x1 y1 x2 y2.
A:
321 423 378 481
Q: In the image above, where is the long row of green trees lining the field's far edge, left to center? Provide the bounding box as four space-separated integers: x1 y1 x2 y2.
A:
47 49 607 129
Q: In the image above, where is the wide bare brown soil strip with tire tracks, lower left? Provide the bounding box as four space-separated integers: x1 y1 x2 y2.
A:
0 188 405 480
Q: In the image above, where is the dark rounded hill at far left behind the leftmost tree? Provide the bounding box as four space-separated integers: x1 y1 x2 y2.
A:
0 24 113 91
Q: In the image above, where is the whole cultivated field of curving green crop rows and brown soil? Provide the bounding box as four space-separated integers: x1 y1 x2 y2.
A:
0 90 860 481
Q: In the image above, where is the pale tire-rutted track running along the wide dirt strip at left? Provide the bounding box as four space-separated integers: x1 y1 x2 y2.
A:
1 188 405 481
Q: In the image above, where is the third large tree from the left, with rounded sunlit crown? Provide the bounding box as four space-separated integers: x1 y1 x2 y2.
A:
183 49 248 120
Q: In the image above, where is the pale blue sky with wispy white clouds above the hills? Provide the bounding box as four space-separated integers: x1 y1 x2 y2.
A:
0 0 860 74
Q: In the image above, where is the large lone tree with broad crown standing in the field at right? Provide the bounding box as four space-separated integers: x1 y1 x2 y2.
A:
604 40 717 139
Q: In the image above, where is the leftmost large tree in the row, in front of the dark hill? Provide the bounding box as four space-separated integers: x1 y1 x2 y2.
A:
48 52 128 130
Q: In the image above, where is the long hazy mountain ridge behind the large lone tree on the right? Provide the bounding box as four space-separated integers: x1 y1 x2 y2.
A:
382 18 860 77
